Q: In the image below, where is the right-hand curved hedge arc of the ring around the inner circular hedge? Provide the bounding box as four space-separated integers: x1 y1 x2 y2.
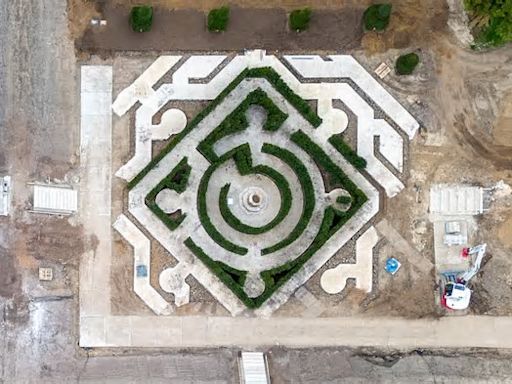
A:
261 143 315 255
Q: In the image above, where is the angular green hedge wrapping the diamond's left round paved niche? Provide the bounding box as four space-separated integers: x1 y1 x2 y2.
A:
145 157 192 231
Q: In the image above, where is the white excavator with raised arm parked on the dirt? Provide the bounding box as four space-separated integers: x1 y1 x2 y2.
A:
441 243 487 310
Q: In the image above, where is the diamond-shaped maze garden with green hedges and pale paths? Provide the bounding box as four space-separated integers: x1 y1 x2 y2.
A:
129 67 367 308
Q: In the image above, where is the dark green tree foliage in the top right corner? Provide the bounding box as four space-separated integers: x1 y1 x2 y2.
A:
464 0 512 46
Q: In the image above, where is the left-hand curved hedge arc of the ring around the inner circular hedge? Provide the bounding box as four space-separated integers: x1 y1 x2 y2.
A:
197 144 250 255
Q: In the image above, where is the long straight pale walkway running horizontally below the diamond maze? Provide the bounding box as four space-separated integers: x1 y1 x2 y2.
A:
80 316 512 349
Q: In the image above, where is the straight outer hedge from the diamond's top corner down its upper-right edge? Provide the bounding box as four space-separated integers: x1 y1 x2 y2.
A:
247 67 322 128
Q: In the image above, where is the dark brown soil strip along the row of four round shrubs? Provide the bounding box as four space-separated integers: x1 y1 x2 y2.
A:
76 4 363 53
